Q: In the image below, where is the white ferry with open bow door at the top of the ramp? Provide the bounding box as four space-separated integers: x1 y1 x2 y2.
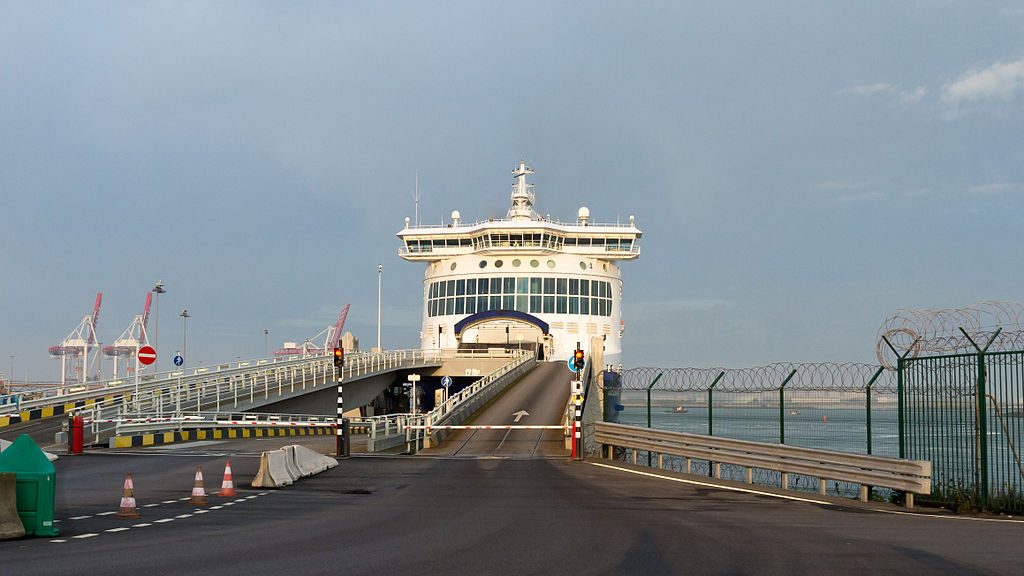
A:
397 162 641 365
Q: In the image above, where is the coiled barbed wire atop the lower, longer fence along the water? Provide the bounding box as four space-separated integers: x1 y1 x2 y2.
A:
621 362 896 392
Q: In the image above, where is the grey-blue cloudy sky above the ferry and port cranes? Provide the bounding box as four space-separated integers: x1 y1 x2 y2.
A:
0 0 1024 381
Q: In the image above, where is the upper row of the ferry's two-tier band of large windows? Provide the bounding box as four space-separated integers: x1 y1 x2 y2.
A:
427 277 611 299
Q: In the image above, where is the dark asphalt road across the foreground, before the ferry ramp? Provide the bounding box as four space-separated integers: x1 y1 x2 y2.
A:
0 360 1024 576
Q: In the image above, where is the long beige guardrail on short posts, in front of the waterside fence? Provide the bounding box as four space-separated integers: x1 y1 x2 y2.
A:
595 416 932 508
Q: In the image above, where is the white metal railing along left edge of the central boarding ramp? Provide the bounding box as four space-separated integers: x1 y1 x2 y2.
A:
360 349 537 452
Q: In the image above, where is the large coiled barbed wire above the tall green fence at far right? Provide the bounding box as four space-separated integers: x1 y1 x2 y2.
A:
876 300 1024 370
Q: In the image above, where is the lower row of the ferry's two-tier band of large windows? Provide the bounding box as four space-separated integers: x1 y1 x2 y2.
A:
427 294 611 317
